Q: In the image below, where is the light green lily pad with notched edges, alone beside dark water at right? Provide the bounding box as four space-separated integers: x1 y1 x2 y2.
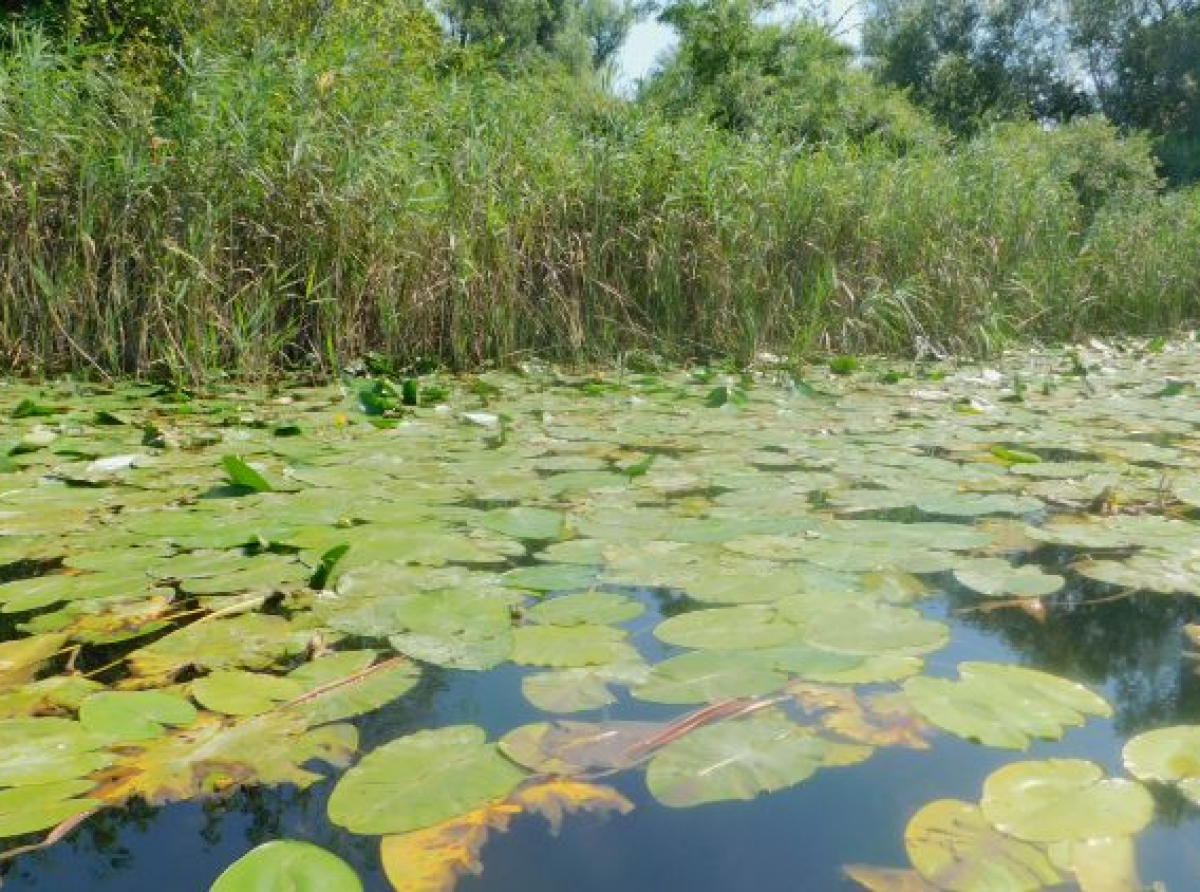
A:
904 663 1112 749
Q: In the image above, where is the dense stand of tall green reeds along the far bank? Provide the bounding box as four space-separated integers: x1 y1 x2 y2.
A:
0 31 1200 377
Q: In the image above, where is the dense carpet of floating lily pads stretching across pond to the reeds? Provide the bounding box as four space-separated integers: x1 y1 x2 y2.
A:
0 340 1200 887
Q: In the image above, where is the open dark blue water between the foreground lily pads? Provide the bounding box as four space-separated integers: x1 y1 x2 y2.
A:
5 595 1200 892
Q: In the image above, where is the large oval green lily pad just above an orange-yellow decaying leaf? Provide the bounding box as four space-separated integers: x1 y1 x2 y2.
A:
329 725 524 836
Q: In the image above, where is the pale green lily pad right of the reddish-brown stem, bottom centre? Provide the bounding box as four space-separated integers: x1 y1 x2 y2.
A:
646 716 871 808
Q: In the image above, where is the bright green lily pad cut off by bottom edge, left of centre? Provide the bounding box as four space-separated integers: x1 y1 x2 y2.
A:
210 839 362 892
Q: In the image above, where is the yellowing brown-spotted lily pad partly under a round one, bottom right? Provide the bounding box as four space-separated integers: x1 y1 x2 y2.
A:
905 800 1061 892
